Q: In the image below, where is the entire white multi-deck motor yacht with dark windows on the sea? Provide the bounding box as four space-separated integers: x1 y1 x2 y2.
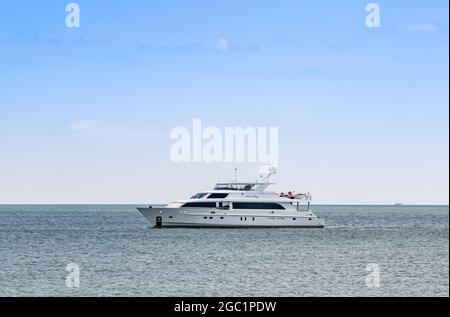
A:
138 173 324 228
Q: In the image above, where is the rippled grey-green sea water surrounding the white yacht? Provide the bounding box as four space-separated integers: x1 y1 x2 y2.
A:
0 205 449 296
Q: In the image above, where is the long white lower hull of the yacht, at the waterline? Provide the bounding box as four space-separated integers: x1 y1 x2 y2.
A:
137 206 324 228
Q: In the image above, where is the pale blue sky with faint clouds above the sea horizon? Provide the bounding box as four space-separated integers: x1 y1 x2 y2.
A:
0 0 449 204
